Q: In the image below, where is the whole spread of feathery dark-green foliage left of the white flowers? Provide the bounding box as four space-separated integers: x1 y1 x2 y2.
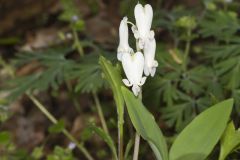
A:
5 48 113 100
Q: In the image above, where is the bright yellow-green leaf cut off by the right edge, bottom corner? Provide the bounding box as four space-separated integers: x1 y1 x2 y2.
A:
219 122 240 160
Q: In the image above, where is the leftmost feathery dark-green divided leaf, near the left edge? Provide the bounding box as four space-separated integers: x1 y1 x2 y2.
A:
5 47 74 100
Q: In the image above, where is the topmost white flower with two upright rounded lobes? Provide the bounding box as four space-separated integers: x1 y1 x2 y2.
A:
132 4 154 49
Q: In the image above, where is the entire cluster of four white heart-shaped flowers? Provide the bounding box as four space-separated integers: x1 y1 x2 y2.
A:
117 4 158 96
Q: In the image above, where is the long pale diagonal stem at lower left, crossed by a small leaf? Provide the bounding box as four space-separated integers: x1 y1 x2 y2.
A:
28 94 94 160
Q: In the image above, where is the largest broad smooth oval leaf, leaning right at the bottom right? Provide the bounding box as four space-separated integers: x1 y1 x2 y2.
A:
169 99 233 160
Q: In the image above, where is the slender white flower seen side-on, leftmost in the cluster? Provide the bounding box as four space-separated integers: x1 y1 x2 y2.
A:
117 17 133 61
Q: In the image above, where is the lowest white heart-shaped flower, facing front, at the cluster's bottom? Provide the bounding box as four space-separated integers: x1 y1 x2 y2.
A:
122 52 146 96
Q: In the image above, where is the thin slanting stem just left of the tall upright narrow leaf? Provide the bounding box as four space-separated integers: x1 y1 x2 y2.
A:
92 92 109 135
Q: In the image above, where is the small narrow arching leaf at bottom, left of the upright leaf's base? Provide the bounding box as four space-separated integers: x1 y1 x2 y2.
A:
91 125 118 160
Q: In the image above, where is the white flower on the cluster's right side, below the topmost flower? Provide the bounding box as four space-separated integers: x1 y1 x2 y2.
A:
143 38 158 77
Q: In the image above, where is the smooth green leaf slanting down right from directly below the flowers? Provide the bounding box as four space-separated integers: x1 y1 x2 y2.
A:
122 87 168 160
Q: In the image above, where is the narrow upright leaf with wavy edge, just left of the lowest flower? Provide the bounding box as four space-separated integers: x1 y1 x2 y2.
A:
99 56 124 123
